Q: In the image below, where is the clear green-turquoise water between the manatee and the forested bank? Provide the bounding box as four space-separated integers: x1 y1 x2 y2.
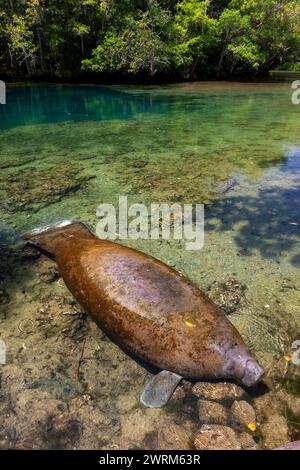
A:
0 82 300 351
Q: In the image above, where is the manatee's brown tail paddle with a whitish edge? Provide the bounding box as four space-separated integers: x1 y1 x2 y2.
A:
22 220 91 256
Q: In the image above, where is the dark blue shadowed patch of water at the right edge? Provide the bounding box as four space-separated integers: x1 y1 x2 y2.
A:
206 178 300 266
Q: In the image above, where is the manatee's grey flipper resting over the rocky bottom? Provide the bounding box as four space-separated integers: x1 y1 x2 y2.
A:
141 370 182 408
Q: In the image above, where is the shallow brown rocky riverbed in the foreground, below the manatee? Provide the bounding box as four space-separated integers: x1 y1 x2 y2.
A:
0 244 300 450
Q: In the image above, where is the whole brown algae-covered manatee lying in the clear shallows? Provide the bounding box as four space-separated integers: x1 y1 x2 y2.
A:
24 221 264 407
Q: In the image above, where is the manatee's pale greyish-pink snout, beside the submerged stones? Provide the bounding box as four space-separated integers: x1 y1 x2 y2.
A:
223 345 264 387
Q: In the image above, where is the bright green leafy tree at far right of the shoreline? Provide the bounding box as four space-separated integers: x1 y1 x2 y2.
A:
218 0 300 75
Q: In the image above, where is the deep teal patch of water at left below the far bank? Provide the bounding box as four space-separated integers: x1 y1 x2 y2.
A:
0 86 158 128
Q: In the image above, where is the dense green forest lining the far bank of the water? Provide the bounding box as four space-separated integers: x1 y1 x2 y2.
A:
0 0 300 80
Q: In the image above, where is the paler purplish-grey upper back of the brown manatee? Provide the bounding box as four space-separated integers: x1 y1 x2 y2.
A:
81 242 216 319
